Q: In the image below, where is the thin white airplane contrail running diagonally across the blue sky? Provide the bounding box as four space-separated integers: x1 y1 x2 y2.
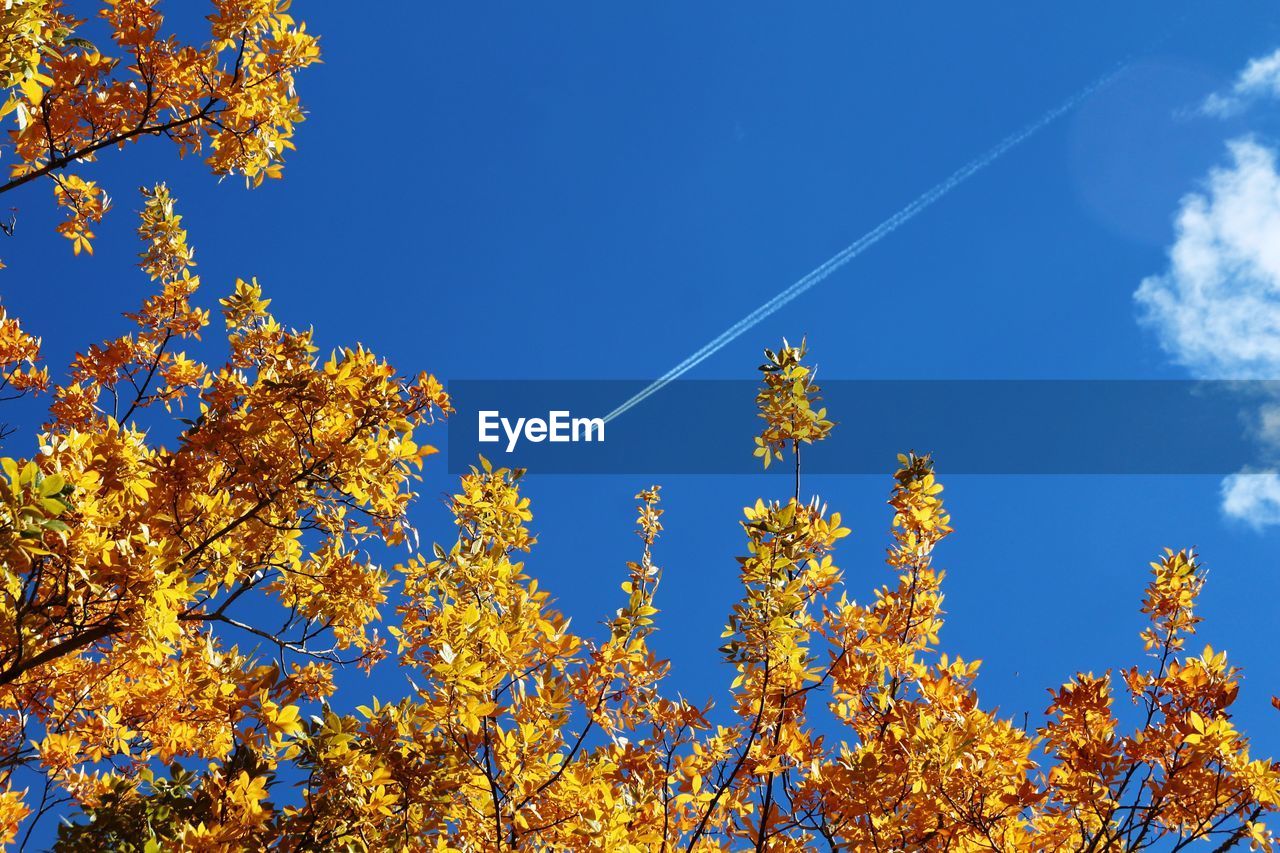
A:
604 64 1128 423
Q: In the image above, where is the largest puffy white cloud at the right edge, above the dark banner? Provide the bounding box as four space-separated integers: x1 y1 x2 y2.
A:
1134 138 1280 379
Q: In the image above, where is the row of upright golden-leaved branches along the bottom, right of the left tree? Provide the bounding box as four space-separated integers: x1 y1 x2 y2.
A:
240 340 1280 850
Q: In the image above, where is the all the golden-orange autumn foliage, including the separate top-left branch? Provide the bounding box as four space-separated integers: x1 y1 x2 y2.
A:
0 0 1280 852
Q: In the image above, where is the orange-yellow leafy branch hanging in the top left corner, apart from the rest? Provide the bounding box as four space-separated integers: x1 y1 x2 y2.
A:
0 0 320 261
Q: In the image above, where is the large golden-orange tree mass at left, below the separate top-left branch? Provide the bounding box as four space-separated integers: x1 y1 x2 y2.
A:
0 184 449 843
